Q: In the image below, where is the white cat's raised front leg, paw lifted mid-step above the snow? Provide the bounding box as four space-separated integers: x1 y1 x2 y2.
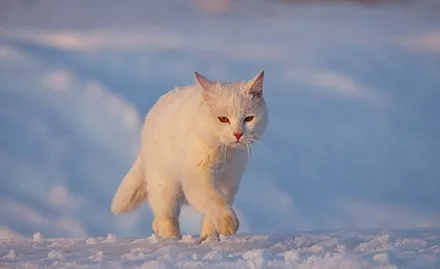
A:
182 171 239 235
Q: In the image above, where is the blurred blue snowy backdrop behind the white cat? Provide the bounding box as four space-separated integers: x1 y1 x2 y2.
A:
0 1 440 239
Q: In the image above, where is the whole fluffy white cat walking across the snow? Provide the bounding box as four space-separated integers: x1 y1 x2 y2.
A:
111 71 268 240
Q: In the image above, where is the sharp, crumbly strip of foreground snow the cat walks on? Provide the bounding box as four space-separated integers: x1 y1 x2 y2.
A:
0 230 440 269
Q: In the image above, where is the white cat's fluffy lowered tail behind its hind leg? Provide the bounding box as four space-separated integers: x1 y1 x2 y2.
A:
111 154 147 215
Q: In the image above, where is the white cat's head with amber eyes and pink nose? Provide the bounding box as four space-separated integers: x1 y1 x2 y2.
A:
194 71 267 148
